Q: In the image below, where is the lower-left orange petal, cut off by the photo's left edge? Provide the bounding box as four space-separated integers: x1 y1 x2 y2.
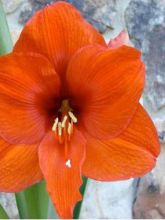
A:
0 139 43 192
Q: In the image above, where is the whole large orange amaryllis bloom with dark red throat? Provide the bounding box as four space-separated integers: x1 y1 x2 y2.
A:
0 2 159 218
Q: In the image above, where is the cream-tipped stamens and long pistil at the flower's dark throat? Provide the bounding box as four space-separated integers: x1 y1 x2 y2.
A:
52 99 77 168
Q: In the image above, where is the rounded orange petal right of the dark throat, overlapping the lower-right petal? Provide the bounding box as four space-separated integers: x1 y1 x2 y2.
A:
67 46 145 139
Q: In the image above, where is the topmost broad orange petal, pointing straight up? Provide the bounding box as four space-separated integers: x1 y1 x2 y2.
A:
15 2 105 78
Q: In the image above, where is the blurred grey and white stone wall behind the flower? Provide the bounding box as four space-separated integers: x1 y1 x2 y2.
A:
0 0 165 219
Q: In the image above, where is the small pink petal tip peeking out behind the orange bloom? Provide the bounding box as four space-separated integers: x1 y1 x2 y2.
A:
108 30 130 48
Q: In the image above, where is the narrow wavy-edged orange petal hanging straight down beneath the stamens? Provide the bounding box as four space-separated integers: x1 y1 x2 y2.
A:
39 130 85 218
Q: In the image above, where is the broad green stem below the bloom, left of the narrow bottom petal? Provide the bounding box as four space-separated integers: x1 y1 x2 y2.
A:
15 181 57 219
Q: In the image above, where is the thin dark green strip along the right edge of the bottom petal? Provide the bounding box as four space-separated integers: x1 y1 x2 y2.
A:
73 177 88 219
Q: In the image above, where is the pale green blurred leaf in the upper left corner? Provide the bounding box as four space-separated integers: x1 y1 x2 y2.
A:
0 0 13 55
